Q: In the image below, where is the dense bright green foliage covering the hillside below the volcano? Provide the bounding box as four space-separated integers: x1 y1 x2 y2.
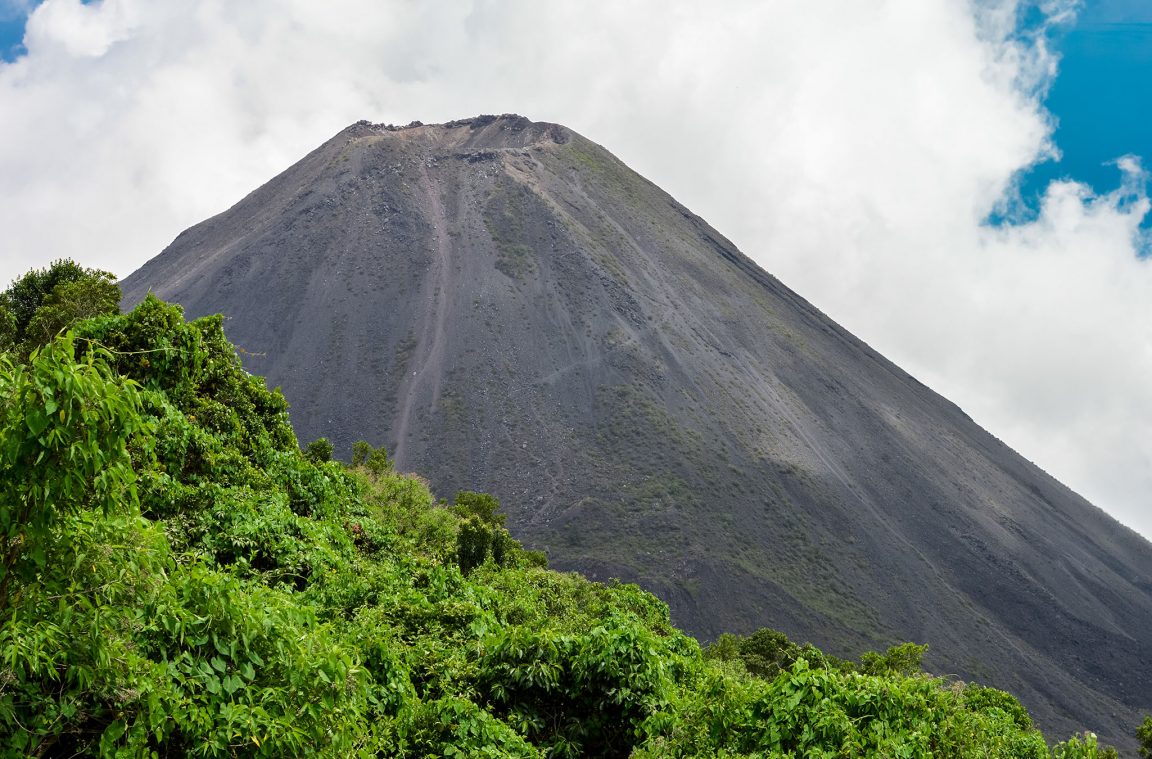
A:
0 266 1138 759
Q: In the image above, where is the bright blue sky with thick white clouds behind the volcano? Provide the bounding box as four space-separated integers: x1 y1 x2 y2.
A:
0 0 1152 537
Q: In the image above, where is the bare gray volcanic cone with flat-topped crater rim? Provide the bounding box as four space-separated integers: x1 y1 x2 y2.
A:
123 116 1152 746
